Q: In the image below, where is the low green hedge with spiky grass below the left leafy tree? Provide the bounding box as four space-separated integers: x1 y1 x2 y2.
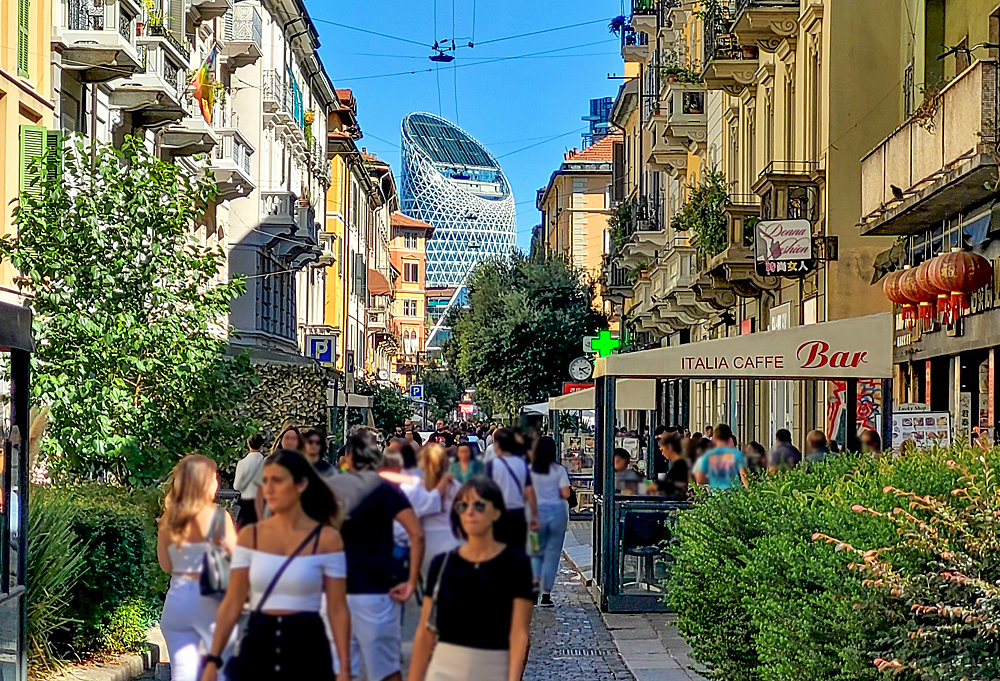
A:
28 484 167 666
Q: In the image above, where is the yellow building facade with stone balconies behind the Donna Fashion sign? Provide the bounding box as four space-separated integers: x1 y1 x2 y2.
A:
604 0 905 446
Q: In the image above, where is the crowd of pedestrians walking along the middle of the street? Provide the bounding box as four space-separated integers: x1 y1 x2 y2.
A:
157 421 570 681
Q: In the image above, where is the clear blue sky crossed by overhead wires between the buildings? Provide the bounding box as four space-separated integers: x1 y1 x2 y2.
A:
307 0 623 248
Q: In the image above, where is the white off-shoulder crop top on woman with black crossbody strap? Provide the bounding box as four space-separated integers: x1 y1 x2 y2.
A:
232 546 347 612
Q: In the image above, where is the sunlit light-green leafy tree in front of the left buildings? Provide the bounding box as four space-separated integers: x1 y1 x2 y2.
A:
0 137 256 484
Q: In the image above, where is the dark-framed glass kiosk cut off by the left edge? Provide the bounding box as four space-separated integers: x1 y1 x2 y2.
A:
0 303 35 681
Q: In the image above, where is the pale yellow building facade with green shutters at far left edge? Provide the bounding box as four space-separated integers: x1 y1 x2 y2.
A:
0 0 55 303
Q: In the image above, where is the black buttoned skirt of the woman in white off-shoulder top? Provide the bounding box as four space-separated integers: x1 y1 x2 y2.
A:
233 612 336 681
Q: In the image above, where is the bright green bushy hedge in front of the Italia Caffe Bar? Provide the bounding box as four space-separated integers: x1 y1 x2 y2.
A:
667 450 976 681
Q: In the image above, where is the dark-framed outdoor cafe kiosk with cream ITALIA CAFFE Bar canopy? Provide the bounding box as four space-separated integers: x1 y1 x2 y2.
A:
593 313 894 612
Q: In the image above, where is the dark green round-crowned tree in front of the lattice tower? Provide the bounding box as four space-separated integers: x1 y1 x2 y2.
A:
453 253 607 413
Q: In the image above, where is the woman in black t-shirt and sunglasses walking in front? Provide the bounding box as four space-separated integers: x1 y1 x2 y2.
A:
409 476 534 681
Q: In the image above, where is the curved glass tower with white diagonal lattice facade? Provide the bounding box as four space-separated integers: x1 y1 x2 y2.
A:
400 113 517 288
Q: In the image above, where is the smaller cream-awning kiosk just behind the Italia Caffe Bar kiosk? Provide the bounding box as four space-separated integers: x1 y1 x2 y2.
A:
548 379 656 520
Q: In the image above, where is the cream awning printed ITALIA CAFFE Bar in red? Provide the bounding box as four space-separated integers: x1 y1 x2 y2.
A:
594 312 895 380
